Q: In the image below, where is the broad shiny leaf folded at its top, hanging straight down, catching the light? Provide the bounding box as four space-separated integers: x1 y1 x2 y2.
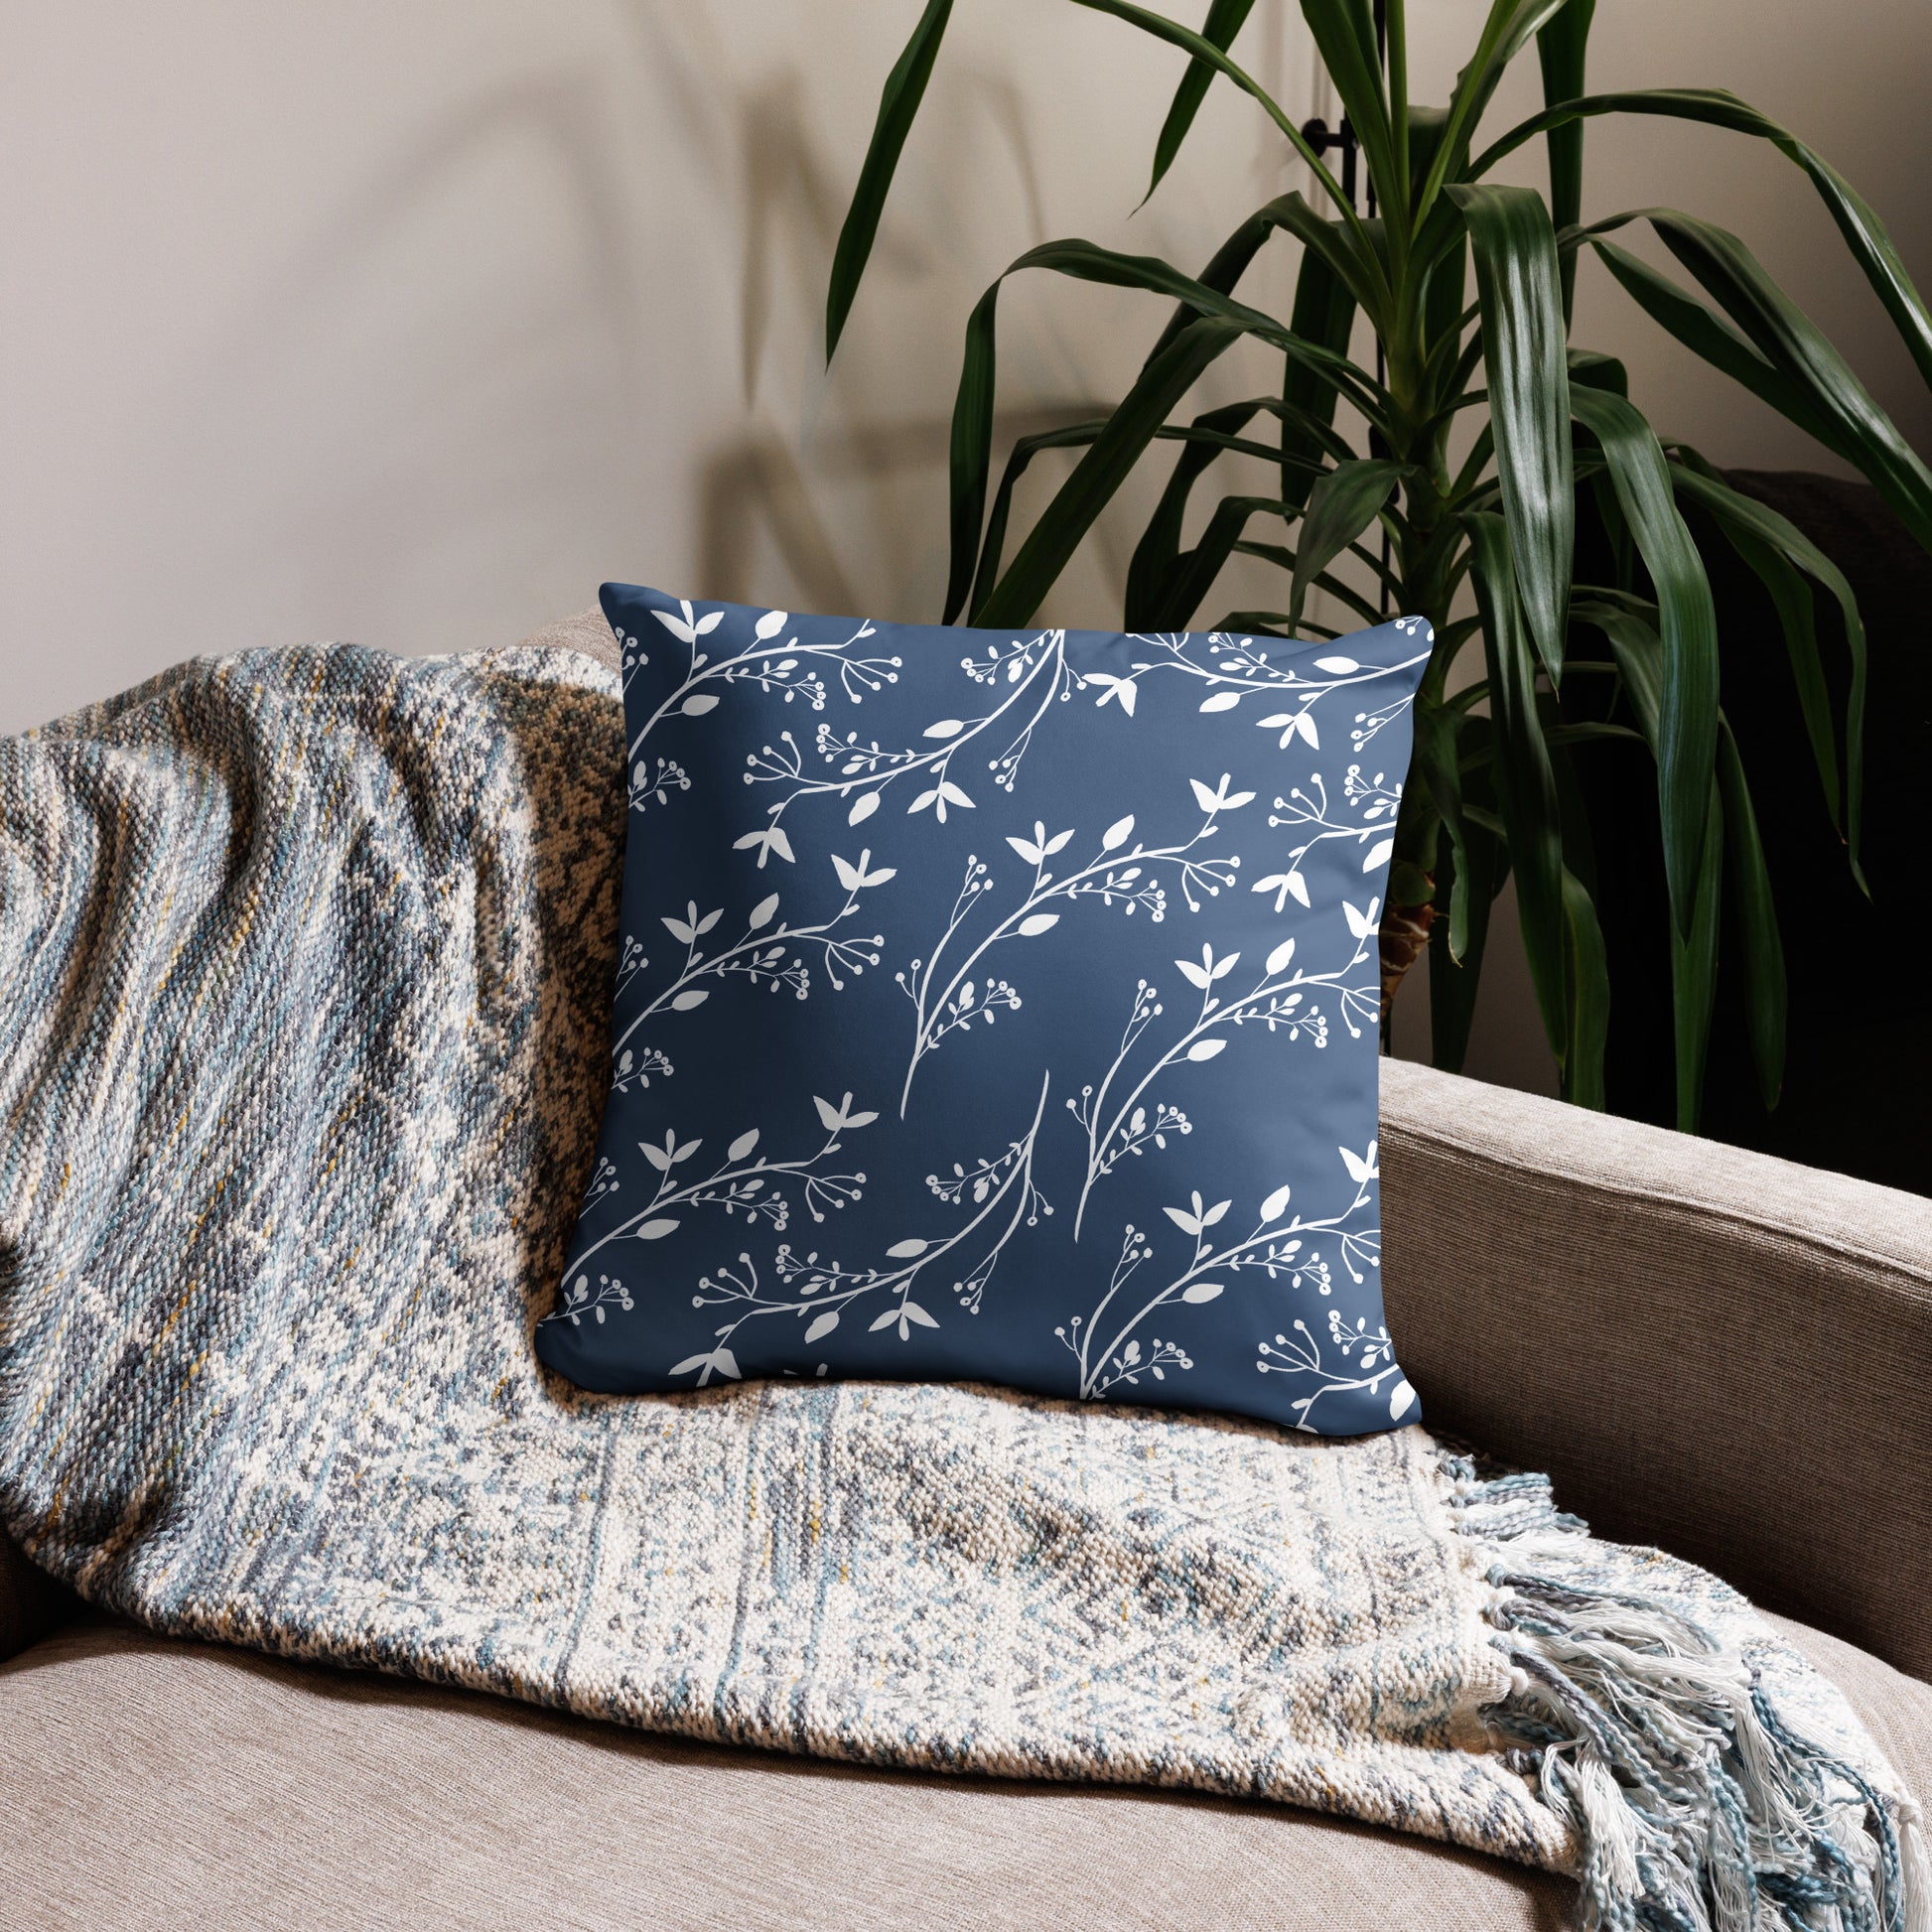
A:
1449 188 1577 679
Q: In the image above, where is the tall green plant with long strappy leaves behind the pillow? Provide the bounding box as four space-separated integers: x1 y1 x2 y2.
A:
825 0 1932 1128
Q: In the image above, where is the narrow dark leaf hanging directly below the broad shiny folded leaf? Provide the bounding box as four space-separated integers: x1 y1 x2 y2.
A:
1462 512 1569 1064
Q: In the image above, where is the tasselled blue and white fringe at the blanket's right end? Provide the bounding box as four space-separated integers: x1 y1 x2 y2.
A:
1448 1456 1932 1932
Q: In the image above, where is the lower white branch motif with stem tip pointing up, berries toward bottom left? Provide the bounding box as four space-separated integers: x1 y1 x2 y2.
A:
670 1072 1053 1389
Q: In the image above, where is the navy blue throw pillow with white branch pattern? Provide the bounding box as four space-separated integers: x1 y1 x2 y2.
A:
537 584 1430 1436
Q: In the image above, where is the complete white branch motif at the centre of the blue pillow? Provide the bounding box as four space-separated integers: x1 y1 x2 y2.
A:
895 772 1254 1119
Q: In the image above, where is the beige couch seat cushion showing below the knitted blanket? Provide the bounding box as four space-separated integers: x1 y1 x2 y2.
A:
0 1623 1932 1932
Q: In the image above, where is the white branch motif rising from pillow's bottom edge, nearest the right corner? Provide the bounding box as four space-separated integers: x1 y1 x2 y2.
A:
1053 1142 1381 1401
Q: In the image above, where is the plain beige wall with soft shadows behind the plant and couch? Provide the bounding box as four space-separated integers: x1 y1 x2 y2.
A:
0 0 1932 1080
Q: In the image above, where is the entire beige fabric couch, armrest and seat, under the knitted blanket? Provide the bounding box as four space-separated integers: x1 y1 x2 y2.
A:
0 1064 1932 1932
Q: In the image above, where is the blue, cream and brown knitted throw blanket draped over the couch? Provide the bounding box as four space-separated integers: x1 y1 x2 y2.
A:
0 647 1928 1932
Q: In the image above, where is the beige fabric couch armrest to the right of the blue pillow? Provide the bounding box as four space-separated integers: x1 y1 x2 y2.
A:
1381 1060 1932 1677
